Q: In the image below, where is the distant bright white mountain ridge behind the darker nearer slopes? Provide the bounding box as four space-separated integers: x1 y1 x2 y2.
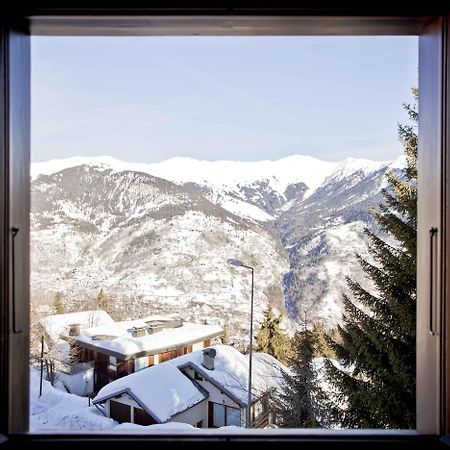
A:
32 155 337 221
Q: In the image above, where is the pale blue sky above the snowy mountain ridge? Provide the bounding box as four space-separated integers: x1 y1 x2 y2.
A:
31 36 418 162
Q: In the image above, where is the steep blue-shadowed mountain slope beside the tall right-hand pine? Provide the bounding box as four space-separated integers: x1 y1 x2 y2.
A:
278 158 404 326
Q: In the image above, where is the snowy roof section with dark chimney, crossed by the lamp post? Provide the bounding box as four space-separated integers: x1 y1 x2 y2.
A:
171 345 288 406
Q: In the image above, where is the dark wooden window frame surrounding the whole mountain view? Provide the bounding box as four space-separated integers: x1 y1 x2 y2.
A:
0 4 450 448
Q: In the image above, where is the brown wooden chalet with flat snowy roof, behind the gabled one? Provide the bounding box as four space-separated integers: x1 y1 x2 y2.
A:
60 316 223 392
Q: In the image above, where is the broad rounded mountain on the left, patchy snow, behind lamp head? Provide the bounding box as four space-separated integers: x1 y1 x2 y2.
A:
31 164 289 348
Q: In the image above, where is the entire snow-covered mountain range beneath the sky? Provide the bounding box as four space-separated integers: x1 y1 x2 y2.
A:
32 155 404 334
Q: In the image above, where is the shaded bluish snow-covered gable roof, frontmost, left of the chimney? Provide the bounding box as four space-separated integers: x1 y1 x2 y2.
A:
93 358 206 423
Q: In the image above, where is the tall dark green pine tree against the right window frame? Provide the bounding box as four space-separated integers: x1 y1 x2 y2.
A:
327 90 418 428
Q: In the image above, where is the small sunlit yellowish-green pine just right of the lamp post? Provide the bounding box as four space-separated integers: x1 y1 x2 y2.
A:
255 303 290 363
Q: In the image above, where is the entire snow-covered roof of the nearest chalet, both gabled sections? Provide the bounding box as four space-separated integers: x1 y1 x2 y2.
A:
93 345 287 422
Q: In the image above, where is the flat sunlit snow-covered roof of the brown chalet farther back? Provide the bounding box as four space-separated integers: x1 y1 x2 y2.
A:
70 317 223 359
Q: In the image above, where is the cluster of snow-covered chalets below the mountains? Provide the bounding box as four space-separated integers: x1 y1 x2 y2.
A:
32 310 287 428
